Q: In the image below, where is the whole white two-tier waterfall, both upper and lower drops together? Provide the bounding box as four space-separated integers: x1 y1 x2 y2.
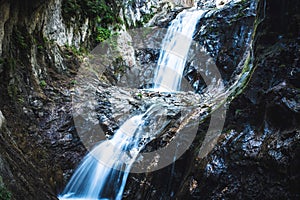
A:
58 9 203 200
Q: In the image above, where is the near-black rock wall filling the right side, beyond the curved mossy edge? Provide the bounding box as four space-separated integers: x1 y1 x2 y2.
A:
178 1 300 199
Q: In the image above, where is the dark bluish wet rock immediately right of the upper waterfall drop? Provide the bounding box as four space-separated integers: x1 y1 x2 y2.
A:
192 1 256 85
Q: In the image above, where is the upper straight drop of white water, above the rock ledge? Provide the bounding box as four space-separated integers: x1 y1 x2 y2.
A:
153 10 204 91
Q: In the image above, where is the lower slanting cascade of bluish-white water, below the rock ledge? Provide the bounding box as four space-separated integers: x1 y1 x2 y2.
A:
59 105 168 200
